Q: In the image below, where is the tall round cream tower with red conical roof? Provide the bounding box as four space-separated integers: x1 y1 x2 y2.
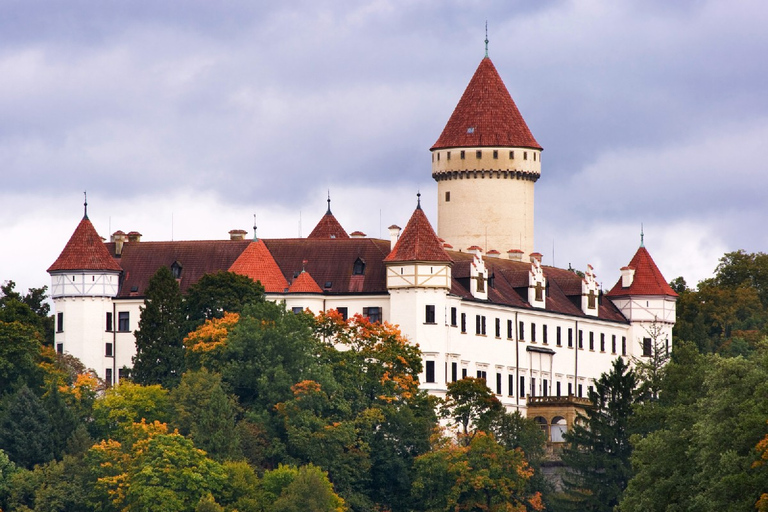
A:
430 56 542 254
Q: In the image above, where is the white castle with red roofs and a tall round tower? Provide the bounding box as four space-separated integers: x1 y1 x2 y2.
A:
48 55 676 441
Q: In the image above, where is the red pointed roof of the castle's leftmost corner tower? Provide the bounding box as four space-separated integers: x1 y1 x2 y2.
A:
48 217 122 272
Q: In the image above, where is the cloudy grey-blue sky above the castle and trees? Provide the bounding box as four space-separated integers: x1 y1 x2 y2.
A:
0 0 768 290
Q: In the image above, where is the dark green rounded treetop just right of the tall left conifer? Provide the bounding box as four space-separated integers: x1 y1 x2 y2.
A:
184 270 264 332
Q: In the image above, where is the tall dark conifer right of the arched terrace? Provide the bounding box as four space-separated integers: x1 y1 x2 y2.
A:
562 358 637 512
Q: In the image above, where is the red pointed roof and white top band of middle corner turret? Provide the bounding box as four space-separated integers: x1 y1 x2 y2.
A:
384 196 453 290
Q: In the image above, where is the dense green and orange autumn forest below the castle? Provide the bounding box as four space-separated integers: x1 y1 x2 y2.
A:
0 251 768 512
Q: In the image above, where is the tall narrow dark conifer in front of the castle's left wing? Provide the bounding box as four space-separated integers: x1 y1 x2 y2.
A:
132 267 184 388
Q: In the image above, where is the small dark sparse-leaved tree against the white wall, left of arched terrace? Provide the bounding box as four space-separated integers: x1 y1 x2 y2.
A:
440 377 503 442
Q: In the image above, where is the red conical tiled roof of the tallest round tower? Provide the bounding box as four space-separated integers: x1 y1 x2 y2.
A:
431 57 542 150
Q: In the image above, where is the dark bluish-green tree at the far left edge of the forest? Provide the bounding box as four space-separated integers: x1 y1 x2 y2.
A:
0 386 53 468
